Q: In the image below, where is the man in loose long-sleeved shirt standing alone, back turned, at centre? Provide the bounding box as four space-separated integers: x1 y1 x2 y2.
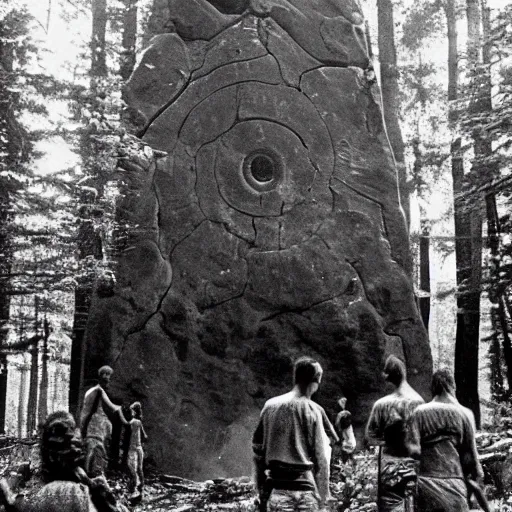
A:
253 357 331 512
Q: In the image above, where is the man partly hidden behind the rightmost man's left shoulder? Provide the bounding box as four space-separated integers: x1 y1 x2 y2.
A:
366 355 424 512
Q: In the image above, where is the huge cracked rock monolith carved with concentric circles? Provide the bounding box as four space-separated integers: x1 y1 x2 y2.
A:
86 0 431 478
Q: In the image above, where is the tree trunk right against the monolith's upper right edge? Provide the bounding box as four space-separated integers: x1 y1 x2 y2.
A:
377 0 410 227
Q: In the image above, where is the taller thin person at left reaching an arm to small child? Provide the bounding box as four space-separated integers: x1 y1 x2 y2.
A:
80 366 126 477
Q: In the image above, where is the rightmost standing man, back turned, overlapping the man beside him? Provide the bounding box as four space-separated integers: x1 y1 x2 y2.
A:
411 369 483 512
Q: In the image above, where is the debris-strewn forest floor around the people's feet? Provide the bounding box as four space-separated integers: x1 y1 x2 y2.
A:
0 432 512 512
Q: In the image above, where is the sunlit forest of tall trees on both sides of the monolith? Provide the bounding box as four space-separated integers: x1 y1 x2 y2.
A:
0 0 512 506
